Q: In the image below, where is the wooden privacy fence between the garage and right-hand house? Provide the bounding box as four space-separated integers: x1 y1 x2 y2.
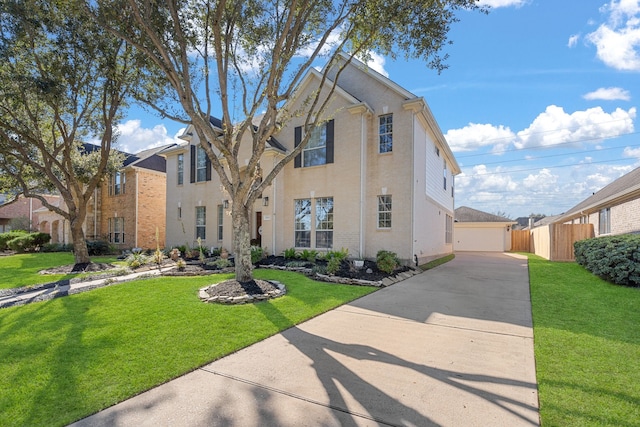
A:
511 224 595 261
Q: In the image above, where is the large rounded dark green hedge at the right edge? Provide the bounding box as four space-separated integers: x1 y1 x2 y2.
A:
573 234 640 286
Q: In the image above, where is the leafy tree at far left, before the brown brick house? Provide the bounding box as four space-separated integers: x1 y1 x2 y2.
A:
0 0 137 264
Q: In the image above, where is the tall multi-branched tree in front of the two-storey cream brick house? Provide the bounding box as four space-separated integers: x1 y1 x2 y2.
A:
91 0 479 282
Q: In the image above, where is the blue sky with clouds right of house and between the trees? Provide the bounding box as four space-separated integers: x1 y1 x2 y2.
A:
115 0 640 218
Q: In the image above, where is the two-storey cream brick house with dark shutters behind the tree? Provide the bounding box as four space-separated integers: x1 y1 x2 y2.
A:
162 56 460 263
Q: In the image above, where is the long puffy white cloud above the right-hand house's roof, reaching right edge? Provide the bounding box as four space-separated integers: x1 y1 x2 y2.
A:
514 105 636 148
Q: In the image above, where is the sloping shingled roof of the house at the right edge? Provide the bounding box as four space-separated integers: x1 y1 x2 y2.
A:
560 167 640 221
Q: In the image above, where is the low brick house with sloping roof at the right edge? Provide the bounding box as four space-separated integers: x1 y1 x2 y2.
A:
556 168 640 237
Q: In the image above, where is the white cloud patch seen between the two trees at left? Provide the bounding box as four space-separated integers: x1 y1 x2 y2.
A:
110 119 184 153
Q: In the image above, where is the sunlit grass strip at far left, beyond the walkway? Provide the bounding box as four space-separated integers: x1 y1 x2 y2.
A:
0 252 121 289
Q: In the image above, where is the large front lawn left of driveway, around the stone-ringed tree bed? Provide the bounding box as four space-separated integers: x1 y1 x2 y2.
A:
0 270 375 426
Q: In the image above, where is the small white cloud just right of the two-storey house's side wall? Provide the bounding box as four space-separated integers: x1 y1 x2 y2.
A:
444 123 516 153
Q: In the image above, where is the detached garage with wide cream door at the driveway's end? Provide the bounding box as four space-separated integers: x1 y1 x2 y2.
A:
453 206 518 252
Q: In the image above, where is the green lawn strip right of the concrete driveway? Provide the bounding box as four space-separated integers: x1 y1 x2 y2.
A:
529 255 640 426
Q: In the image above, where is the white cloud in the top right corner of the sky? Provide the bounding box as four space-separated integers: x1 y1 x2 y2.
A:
586 0 640 71
